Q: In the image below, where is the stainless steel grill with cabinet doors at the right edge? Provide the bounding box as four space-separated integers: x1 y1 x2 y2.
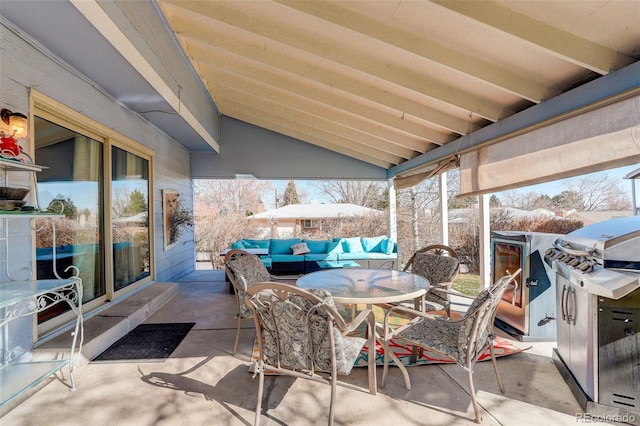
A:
545 216 640 424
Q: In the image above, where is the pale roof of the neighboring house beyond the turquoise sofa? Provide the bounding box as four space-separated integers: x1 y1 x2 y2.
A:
249 204 383 220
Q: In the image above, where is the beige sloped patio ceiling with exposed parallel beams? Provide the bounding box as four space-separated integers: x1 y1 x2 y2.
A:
157 0 640 169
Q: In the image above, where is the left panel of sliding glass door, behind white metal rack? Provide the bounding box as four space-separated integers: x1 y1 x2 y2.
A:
35 117 106 323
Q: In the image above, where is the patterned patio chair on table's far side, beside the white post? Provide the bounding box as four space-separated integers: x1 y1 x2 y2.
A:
403 244 460 317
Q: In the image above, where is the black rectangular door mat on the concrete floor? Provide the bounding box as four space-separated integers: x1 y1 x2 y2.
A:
92 322 196 362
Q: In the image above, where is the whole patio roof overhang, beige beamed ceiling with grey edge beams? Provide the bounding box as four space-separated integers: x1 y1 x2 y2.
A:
1 0 640 189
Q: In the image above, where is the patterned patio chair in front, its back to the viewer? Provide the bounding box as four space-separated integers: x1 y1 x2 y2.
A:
247 282 376 425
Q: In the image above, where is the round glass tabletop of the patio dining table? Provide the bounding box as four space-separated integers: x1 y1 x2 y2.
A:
296 268 429 304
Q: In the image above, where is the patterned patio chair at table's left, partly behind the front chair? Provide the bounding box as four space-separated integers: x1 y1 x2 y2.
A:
224 250 295 355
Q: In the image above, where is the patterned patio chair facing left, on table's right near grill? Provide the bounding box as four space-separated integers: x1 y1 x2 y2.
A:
382 269 521 423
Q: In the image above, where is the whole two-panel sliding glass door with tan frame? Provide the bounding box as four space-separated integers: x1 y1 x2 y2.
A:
33 113 152 332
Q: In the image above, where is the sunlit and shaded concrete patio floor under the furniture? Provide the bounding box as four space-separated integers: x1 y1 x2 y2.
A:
0 271 582 426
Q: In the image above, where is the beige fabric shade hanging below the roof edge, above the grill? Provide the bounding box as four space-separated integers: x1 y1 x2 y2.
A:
460 91 640 197
